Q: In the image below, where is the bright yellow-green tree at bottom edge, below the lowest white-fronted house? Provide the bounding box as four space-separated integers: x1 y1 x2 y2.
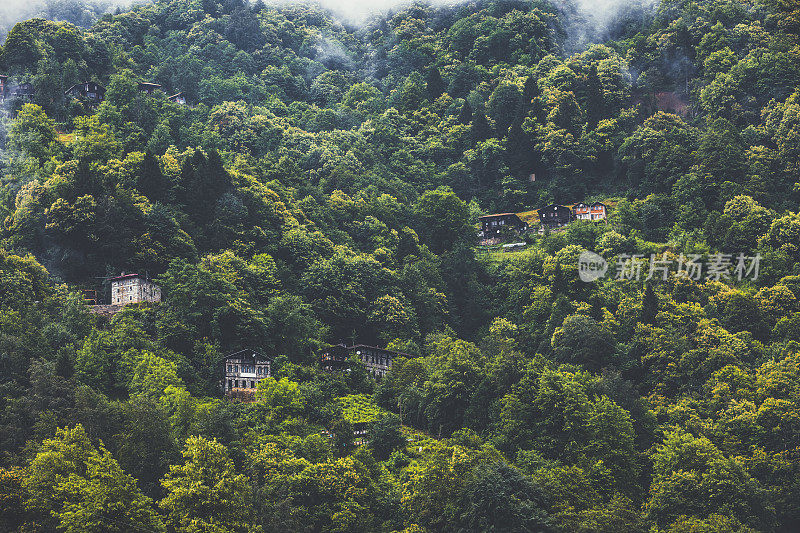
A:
159 437 252 533
